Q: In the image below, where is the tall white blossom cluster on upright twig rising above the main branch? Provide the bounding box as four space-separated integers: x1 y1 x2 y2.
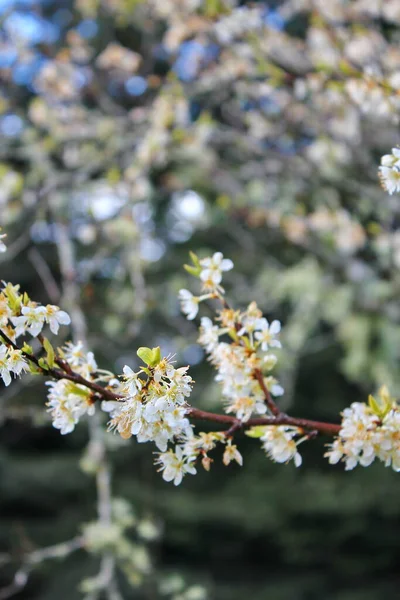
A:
179 252 283 422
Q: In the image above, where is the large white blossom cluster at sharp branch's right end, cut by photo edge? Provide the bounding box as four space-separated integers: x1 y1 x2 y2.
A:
325 386 400 471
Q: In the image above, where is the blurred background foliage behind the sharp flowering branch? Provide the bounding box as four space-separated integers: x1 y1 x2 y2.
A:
0 0 400 600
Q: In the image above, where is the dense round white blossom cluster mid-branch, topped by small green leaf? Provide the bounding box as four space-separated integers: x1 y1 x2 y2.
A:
102 348 193 452
